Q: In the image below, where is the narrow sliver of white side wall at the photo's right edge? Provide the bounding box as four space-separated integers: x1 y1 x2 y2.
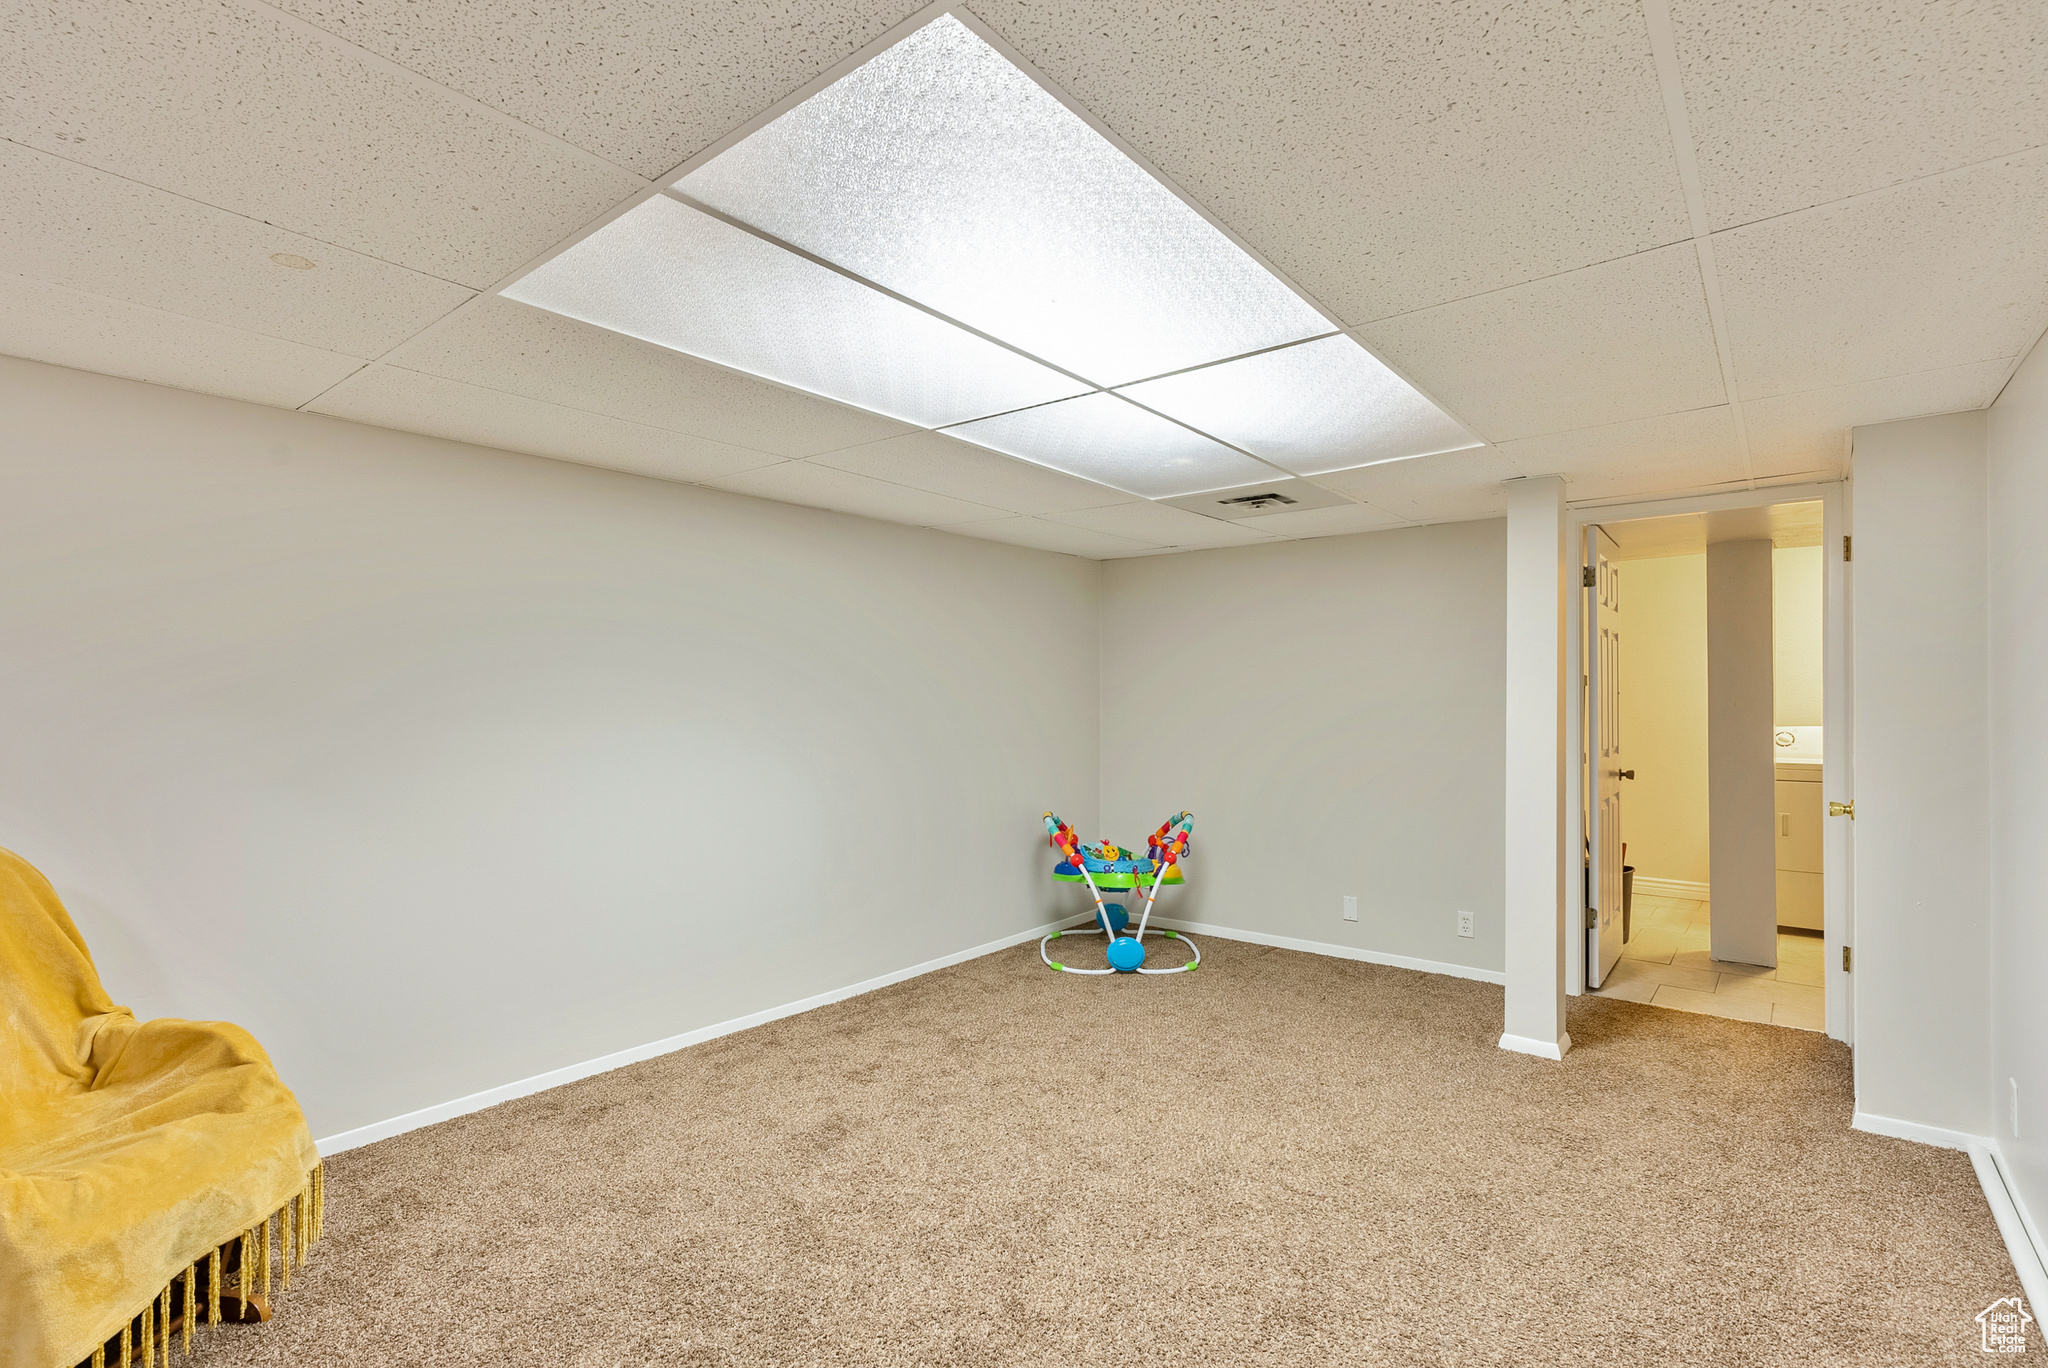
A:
1982 346 2048 1223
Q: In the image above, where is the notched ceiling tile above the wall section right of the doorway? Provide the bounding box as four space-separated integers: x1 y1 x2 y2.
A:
1743 360 2011 479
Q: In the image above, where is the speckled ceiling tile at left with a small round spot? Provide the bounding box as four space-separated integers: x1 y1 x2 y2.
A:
0 141 471 356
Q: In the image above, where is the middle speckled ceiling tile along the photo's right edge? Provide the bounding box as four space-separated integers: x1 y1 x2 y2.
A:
1714 158 2048 401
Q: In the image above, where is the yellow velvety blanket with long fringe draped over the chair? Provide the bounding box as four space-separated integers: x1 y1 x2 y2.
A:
0 850 322 1368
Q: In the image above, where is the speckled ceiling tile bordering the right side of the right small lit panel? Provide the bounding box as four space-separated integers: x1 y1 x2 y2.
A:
1358 242 1726 442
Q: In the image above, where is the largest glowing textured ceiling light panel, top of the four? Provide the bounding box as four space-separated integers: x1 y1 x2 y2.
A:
676 14 1331 385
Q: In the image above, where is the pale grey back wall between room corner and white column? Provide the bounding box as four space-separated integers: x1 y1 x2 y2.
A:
1083 522 1505 971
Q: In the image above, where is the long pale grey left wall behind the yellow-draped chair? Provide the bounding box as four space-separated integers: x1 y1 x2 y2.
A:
0 360 1105 1135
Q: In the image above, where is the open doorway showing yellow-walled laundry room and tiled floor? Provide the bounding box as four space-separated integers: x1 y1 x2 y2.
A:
1567 487 1849 1038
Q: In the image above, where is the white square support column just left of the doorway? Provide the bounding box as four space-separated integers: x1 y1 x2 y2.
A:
1501 475 1579 1059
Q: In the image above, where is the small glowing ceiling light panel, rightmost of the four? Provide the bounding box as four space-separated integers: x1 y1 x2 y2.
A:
1118 336 1479 475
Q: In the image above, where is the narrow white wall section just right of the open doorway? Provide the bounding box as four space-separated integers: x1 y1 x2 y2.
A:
1849 412 1982 1135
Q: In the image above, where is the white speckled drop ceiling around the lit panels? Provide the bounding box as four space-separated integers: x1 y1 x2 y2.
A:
0 0 2048 557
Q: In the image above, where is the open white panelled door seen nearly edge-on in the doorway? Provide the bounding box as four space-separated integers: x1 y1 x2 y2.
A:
1585 526 1634 987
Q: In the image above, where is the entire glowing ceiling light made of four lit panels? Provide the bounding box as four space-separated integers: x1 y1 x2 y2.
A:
504 14 1477 498
